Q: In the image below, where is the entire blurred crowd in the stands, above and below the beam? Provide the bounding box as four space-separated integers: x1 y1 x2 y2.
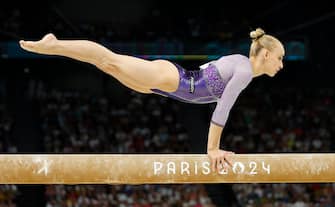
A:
0 75 335 207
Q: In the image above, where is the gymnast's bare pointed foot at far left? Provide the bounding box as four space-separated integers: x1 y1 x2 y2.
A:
20 33 57 55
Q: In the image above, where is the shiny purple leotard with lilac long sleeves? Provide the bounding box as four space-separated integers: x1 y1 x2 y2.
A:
152 54 253 127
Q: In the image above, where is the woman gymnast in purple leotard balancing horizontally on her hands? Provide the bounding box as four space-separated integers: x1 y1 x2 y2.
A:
20 28 285 171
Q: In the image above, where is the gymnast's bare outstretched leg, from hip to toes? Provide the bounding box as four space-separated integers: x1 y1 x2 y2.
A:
20 34 179 93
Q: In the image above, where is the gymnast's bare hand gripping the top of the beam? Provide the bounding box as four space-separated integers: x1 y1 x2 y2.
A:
207 149 235 172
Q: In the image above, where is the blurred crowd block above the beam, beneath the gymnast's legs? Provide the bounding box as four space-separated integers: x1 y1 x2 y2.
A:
39 90 189 153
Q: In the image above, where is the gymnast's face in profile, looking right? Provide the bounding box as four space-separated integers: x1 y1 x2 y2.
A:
263 43 285 77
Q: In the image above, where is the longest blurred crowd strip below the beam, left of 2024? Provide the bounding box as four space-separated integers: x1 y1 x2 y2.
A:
46 185 214 207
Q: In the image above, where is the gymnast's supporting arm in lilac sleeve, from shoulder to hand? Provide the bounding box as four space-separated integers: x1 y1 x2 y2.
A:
207 71 252 171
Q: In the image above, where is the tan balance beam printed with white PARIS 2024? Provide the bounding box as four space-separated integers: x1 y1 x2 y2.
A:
0 153 335 184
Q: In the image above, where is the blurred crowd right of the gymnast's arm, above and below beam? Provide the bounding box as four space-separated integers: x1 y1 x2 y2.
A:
224 87 335 207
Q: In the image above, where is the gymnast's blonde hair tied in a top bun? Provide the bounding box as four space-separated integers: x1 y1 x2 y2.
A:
249 28 281 57
